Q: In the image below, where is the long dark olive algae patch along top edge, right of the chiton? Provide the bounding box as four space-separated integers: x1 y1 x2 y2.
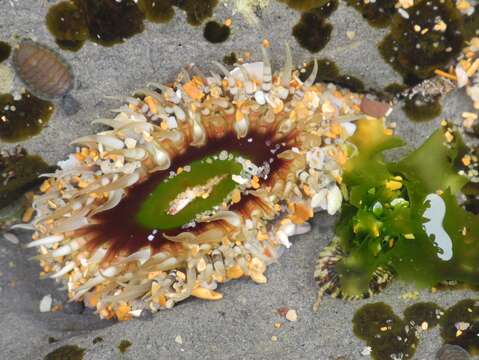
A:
46 0 218 51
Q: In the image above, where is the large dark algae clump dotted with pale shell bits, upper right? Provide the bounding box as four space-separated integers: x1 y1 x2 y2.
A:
379 0 464 85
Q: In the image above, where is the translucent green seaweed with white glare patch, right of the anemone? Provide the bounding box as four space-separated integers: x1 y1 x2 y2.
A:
336 121 479 296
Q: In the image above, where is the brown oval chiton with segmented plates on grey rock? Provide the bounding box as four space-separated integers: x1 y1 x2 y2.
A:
13 40 73 99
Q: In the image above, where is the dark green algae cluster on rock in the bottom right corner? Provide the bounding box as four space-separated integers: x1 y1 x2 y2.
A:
353 299 479 360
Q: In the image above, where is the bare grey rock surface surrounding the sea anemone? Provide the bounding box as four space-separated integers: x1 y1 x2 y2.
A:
0 0 477 360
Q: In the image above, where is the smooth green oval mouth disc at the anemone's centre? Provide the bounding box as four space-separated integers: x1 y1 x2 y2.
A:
136 153 243 230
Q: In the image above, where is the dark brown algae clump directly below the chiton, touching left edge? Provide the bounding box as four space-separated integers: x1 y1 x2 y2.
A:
0 92 54 142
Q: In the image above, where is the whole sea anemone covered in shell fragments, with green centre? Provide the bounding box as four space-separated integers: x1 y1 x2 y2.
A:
28 48 372 320
